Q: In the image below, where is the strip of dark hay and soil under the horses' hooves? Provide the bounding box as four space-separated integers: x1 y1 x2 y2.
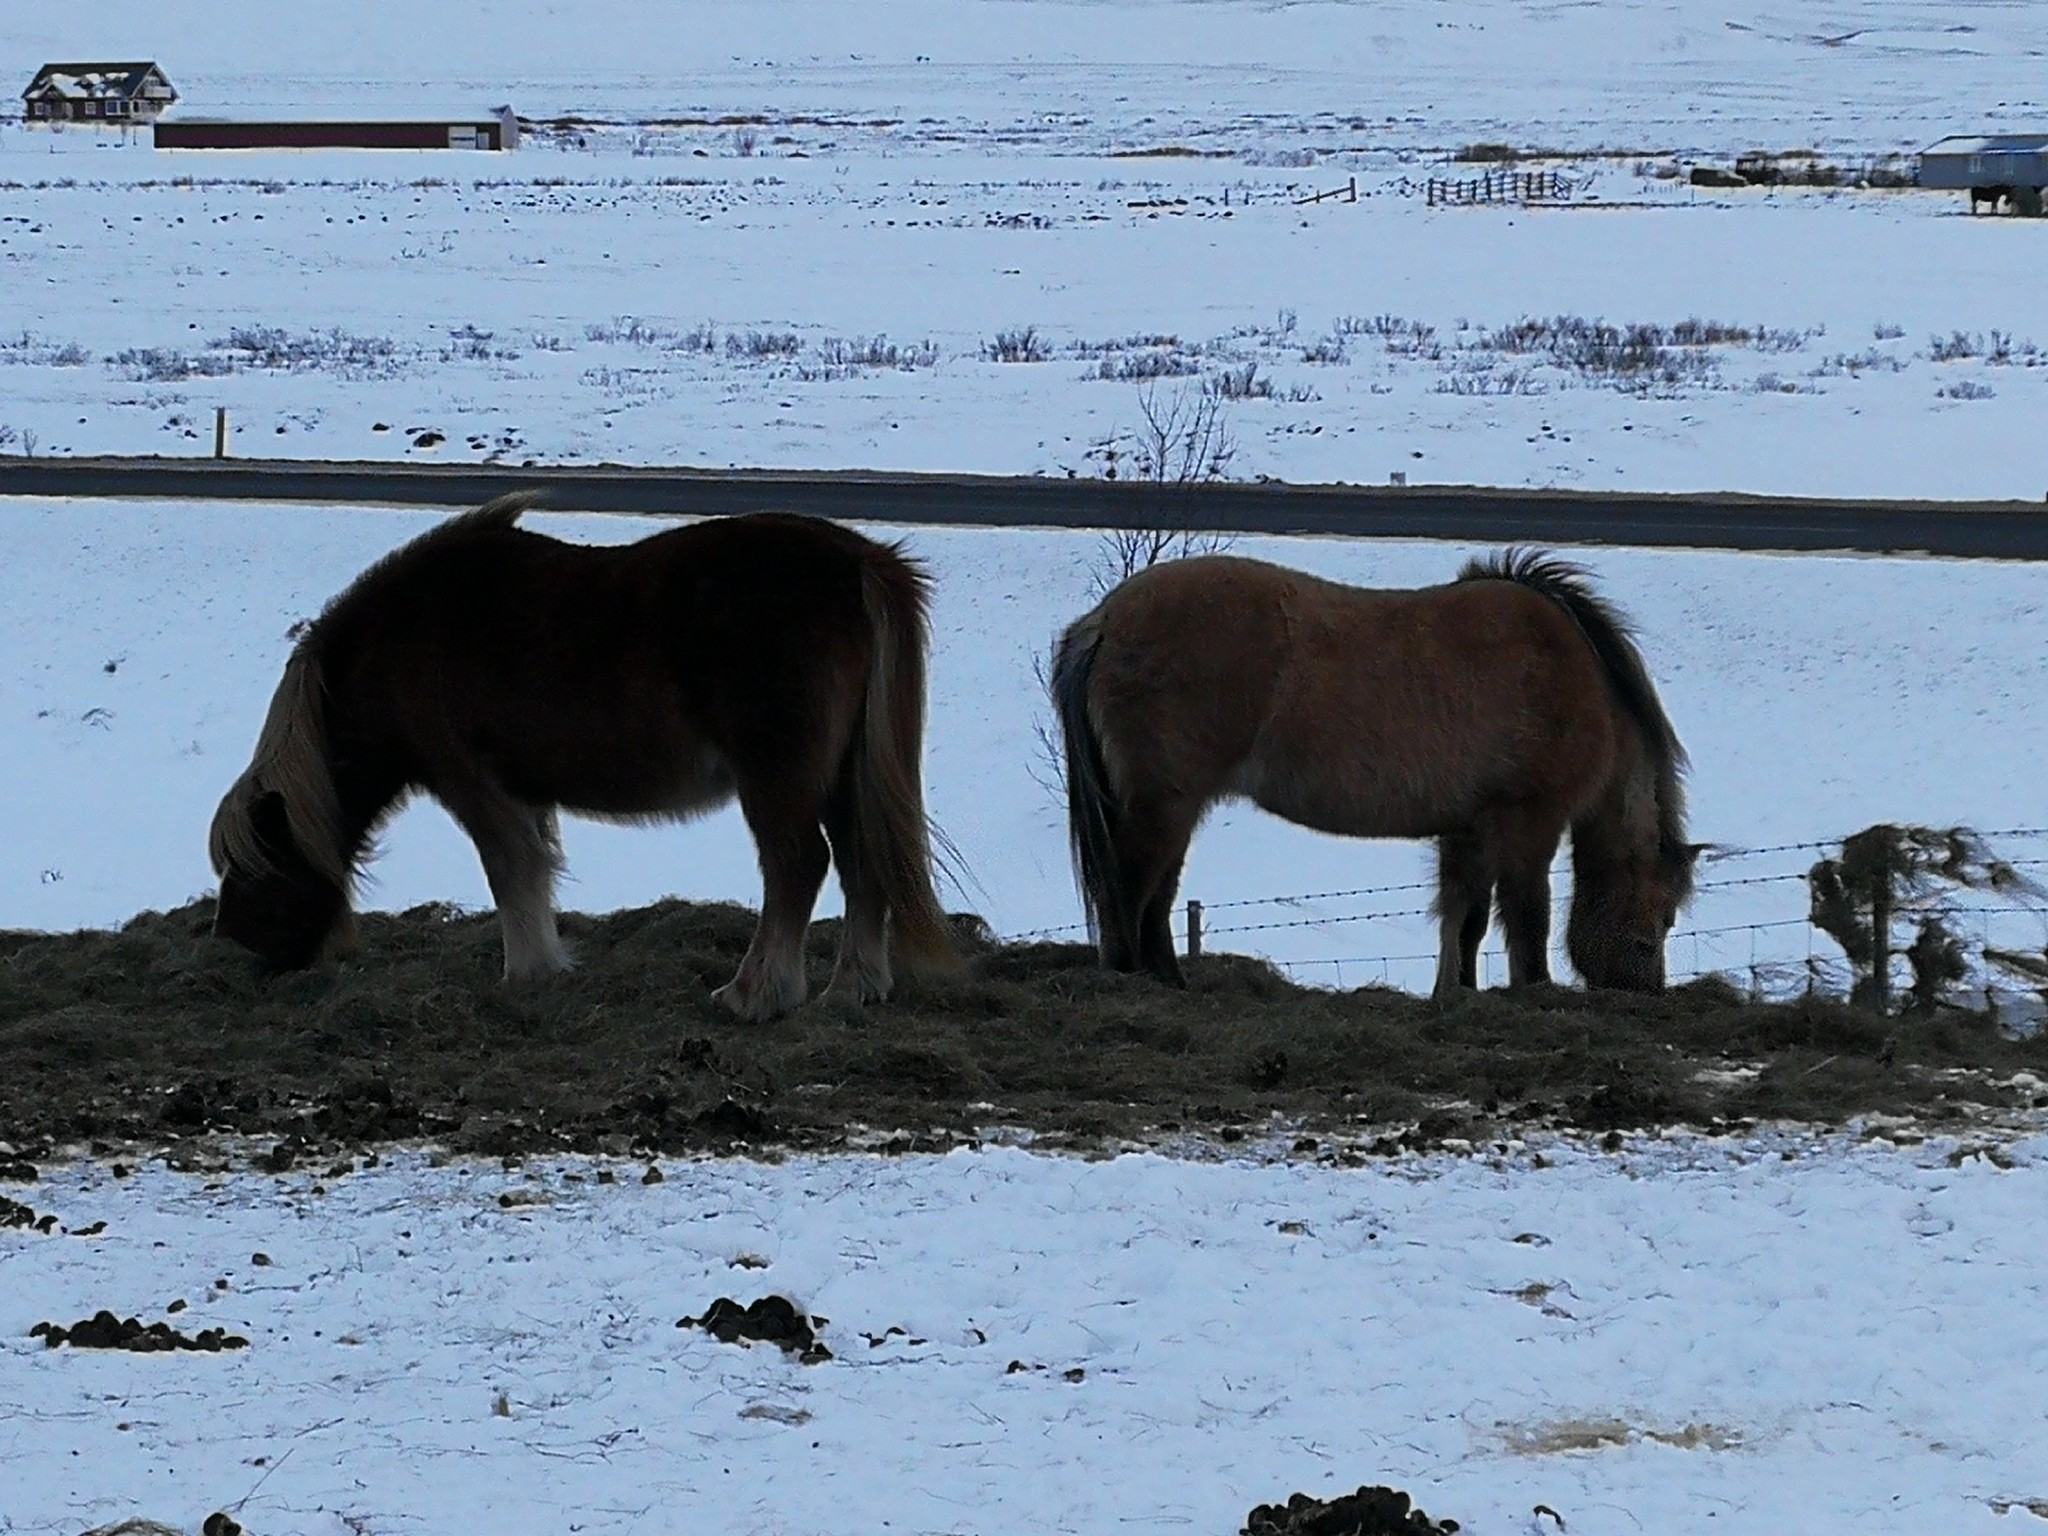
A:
0 901 2048 1174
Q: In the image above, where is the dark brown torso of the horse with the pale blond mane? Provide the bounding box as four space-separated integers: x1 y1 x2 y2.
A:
309 514 897 817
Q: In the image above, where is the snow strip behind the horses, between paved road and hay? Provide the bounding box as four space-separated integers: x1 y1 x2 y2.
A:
0 500 2048 989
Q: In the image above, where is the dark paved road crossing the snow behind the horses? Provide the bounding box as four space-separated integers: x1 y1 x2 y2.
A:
0 459 2048 559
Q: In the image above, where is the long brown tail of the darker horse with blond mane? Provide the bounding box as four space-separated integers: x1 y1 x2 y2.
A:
852 547 961 973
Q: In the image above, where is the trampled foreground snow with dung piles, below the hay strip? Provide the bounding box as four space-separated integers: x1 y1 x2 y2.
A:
0 1137 2048 1536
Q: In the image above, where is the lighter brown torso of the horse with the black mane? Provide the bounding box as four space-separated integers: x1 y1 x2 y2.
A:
1083 557 1618 836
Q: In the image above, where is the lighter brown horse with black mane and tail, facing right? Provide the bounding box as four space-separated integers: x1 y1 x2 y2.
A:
1053 551 1698 997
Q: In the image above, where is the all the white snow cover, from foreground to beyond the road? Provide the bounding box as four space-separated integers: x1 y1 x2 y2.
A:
0 12 2048 1536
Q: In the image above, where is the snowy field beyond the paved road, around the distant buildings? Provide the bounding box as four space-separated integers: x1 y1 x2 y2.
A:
0 0 2048 500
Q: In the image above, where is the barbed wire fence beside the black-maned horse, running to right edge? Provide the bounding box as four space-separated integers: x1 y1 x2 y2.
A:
1010 827 2048 1006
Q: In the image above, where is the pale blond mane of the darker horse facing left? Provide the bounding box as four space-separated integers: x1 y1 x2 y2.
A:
207 492 541 891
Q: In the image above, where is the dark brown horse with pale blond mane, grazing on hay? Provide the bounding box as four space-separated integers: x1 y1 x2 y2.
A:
209 496 954 1018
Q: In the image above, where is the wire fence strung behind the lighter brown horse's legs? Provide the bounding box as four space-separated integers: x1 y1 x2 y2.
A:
1016 827 2048 1018
